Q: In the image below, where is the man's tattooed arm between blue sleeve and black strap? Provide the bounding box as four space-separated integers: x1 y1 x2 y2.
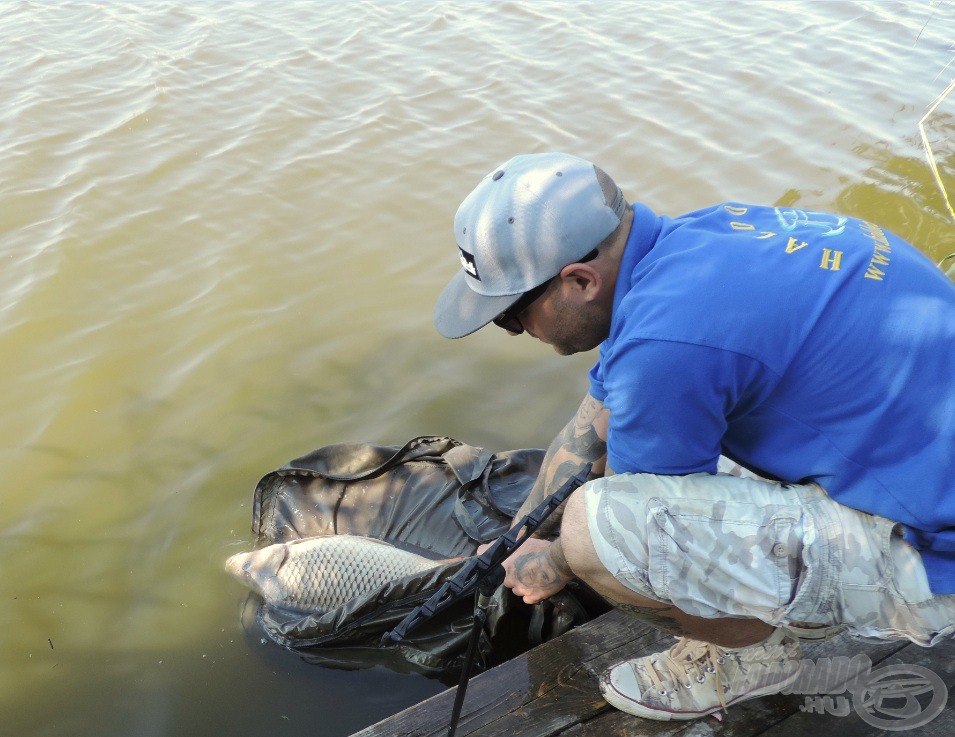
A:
514 394 610 537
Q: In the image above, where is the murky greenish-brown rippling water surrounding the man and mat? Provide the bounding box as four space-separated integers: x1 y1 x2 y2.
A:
0 2 955 737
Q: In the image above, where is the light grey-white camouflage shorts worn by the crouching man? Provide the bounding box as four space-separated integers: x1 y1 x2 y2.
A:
582 473 955 645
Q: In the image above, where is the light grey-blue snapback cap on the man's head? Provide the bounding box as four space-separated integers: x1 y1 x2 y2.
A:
434 153 627 338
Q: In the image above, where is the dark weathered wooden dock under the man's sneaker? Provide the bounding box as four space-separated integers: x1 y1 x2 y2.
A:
352 611 955 737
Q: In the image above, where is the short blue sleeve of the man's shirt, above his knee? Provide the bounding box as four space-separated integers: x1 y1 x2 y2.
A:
591 340 767 475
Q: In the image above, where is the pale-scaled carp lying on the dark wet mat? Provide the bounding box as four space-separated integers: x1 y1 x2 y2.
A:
225 535 460 612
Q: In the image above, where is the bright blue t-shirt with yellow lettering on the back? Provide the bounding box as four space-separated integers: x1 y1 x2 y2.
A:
590 203 955 594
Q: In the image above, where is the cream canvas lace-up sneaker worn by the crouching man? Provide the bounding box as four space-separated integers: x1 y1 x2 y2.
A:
600 629 800 720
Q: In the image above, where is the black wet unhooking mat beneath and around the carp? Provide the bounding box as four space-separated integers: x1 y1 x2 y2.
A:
243 436 609 676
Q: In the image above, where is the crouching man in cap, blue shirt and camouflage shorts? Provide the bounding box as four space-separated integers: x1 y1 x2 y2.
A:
435 153 955 719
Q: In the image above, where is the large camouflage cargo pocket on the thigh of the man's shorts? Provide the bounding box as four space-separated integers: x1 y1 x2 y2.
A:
647 498 802 619
